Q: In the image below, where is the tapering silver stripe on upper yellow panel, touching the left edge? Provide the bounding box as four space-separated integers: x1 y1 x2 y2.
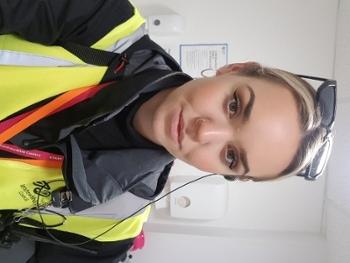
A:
0 50 75 67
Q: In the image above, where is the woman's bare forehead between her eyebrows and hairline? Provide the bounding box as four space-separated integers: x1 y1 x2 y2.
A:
235 78 300 177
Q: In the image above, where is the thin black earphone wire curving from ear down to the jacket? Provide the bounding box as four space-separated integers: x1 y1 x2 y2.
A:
30 173 218 250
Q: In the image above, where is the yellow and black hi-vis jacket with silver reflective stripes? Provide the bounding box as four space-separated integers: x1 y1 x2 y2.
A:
0 0 154 244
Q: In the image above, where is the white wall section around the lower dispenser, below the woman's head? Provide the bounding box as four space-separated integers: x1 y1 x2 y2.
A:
150 174 325 233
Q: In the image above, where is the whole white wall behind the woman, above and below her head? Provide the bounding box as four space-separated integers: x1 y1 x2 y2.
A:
133 0 338 262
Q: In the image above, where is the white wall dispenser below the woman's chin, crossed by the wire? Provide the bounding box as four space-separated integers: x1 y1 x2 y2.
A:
170 176 228 220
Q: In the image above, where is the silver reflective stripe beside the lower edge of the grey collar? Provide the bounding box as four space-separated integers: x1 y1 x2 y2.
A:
48 192 150 219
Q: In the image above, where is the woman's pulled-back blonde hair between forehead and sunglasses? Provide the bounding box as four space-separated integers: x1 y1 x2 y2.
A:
232 62 325 181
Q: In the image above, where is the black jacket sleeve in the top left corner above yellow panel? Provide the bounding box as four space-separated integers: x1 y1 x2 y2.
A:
0 0 134 46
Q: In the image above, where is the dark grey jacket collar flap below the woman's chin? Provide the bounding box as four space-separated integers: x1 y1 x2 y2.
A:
61 136 173 213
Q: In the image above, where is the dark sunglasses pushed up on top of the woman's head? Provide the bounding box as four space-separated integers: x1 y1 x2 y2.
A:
297 75 337 181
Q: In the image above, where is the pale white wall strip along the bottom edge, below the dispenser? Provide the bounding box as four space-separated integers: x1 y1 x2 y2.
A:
132 232 326 263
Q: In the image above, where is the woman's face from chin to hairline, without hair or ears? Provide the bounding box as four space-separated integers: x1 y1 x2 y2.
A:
145 74 301 182
